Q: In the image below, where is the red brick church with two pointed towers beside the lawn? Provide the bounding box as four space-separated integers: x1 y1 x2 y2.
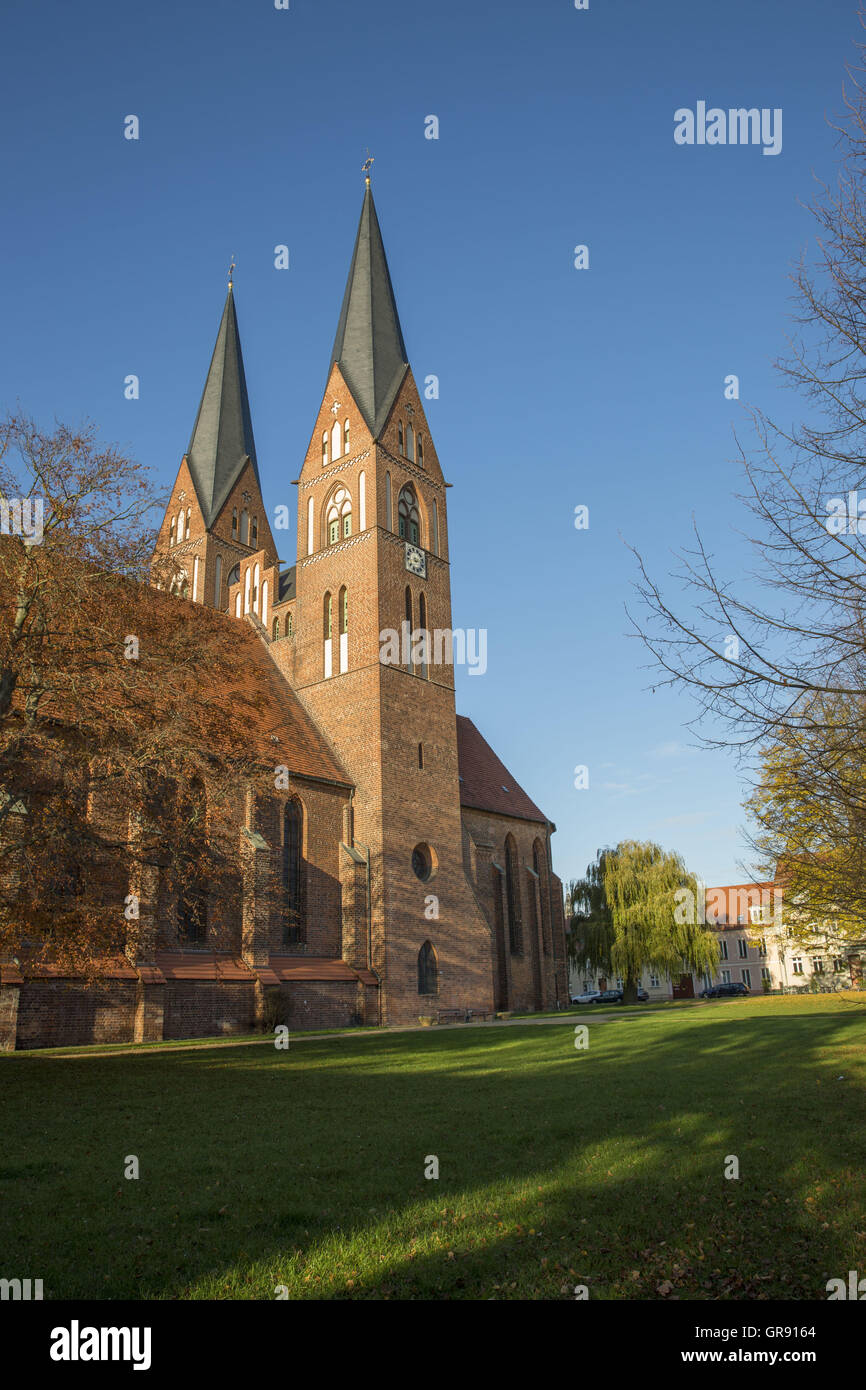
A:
0 179 567 1048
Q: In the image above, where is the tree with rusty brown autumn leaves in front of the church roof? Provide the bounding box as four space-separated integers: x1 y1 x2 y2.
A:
0 414 276 974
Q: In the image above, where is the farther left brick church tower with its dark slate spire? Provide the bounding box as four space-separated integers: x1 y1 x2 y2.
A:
154 269 277 610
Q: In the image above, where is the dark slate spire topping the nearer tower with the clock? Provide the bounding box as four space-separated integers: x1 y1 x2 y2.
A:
331 179 409 438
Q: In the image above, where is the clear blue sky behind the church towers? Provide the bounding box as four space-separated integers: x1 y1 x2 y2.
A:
0 0 859 883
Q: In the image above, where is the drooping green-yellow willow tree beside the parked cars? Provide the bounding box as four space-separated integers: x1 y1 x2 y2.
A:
567 840 719 1004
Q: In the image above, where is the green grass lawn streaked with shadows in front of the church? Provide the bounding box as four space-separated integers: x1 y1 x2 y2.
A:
0 995 866 1300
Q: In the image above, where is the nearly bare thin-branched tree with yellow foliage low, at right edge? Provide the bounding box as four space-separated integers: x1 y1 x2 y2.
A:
635 38 866 916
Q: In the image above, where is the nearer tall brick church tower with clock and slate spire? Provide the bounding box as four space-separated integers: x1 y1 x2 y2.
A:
291 179 492 1023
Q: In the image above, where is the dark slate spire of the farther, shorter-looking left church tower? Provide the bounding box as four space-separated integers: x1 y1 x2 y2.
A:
186 279 261 527
